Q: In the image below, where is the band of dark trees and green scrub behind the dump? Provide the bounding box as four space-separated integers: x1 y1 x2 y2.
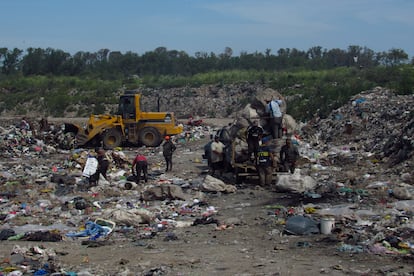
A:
0 46 414 120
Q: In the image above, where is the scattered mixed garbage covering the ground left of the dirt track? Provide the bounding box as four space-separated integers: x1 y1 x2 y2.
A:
0 116 237 275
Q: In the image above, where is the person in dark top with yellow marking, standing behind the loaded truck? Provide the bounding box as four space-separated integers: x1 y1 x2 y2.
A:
256 137 273 186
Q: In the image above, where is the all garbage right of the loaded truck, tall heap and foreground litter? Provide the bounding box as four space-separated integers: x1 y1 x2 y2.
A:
268 87 414 256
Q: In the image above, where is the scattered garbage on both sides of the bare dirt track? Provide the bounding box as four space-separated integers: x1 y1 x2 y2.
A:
0 88 414 275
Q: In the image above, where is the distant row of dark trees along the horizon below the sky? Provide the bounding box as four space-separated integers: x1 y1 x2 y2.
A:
0 46 414 77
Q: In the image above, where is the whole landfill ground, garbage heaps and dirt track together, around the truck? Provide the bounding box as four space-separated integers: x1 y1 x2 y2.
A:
0 87 414 275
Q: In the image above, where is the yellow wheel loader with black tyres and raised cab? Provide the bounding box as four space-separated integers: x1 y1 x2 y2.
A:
64 91 183 149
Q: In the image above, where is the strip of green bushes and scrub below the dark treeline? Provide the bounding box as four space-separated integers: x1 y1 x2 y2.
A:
0 64 414 120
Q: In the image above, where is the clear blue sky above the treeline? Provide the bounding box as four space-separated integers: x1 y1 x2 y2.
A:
0 0 414 58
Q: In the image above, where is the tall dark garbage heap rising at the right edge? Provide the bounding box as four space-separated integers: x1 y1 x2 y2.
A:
303 87 414 166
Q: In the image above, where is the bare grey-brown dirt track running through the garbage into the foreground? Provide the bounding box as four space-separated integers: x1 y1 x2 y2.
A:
0 119 414 275
